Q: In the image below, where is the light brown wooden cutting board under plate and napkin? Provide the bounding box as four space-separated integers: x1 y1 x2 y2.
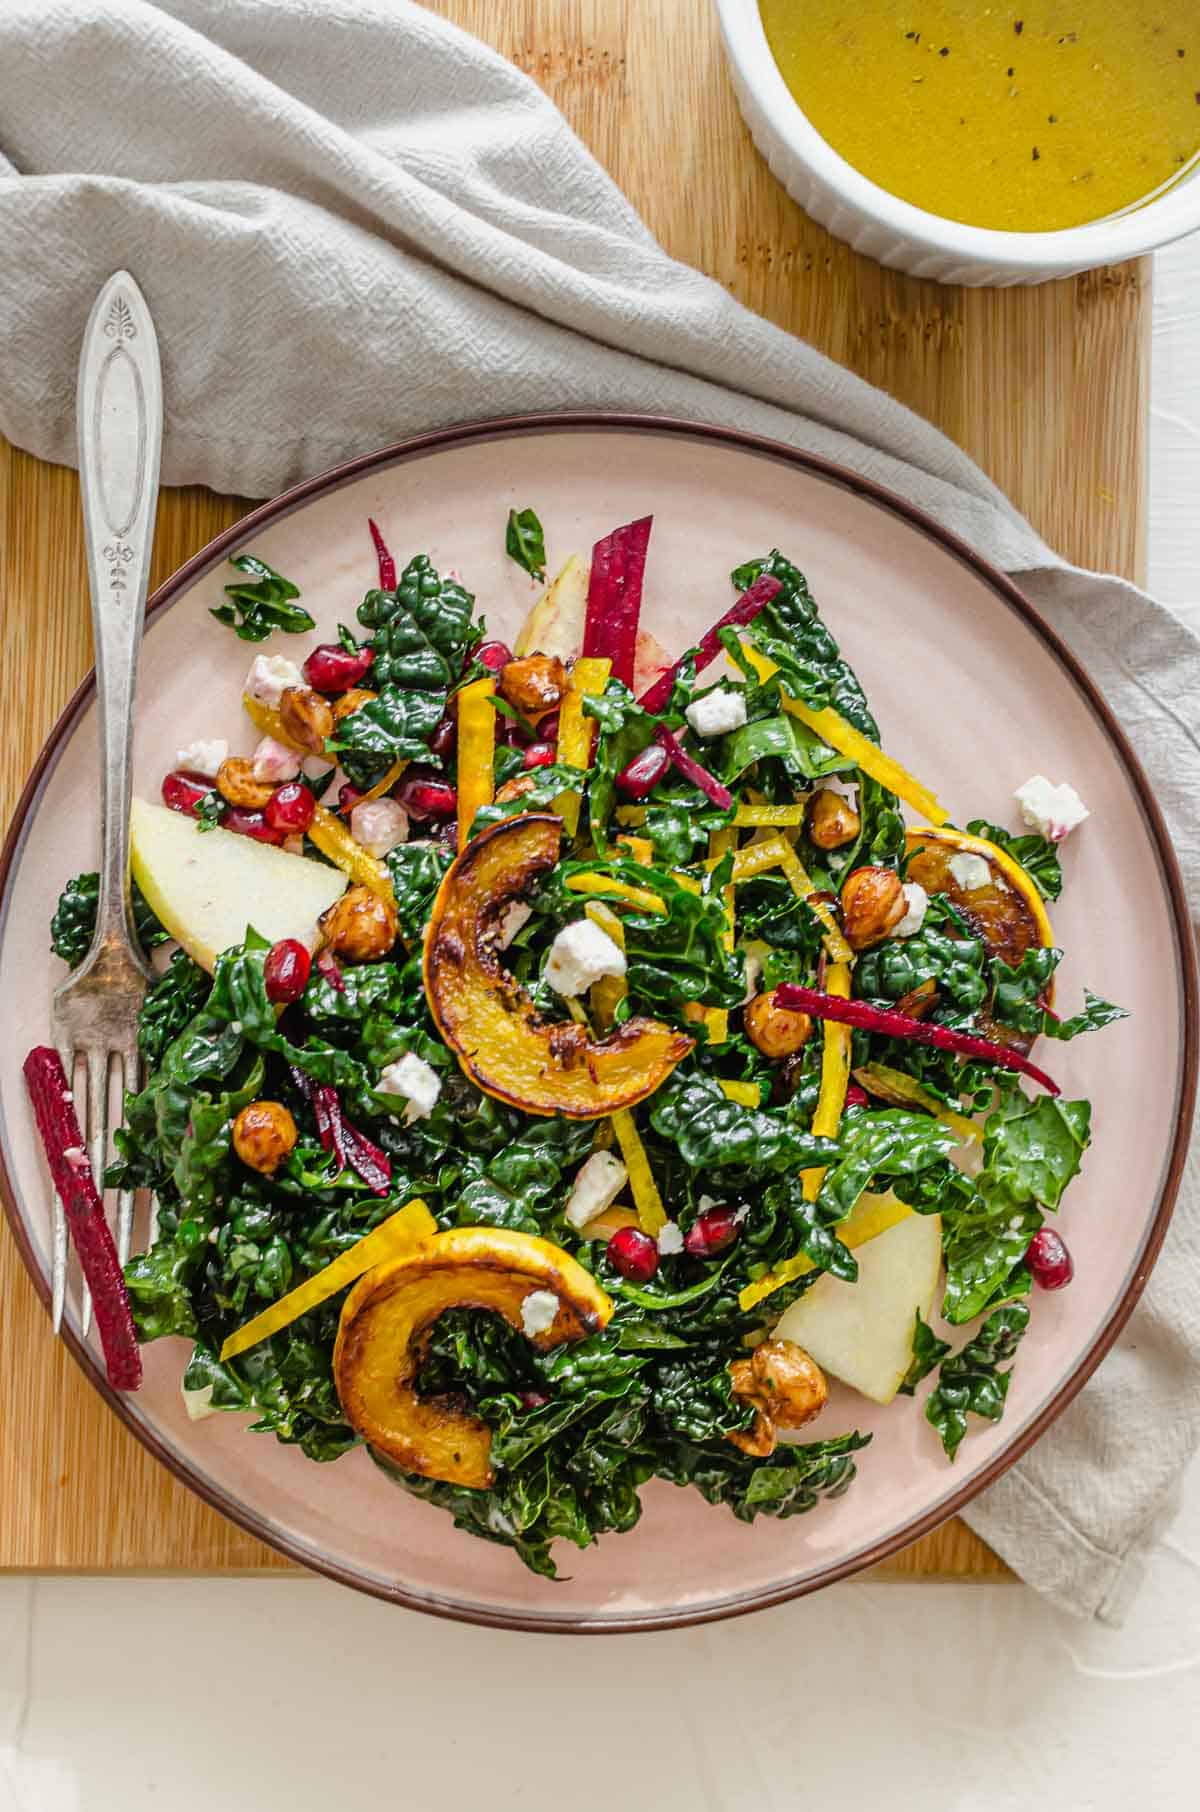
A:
0 0 1149 1578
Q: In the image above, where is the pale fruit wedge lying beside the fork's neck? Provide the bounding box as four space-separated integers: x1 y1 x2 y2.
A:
129 799 346 973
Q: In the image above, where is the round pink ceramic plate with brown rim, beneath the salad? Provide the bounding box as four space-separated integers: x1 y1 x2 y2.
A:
0 417 1196 1631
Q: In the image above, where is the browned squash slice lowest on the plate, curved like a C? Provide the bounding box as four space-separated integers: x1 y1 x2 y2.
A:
334 1227 613 1491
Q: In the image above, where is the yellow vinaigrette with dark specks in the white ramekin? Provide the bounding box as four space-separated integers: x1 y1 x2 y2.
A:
760 0 1200 232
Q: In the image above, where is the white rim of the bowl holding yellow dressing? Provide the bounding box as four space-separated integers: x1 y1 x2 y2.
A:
716 0 1200 274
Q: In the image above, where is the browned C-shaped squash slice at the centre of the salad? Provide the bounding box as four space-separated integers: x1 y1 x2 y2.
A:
424 812 692 1120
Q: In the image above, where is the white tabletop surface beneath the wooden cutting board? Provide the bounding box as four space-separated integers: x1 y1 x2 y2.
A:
0 237 1200 1812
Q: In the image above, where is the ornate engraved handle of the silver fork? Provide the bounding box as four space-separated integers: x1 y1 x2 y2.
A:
76 270 163 966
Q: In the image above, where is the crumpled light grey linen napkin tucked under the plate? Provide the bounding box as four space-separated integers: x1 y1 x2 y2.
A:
0 0 1200 1620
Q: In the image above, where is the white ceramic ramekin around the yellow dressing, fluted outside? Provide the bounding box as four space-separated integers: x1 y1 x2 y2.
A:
716 0 1200 286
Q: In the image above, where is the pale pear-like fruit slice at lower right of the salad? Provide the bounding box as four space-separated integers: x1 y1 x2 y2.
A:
774 1214 941 1402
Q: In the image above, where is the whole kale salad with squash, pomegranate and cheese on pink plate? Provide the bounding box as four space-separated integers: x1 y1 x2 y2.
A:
27 511 1120 1576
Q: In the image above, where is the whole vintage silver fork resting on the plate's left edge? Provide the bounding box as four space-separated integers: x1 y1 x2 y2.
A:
53 270 163 1339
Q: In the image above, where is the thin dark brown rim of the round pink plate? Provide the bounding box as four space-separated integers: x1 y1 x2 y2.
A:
0 410 1200 1634
